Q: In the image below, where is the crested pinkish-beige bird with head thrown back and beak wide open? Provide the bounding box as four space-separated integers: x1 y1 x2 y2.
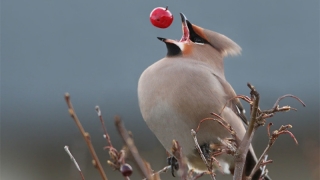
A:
138 13 270 180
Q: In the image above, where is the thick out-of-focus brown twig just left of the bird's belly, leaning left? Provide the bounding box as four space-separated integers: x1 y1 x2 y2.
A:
115 116 152 179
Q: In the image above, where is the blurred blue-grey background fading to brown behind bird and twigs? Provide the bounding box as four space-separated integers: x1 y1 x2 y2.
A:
1 0 319 180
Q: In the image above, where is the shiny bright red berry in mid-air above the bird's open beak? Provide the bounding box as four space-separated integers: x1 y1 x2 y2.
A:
150 6 173 28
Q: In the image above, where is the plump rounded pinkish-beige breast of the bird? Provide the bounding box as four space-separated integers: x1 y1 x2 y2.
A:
138 59 225 142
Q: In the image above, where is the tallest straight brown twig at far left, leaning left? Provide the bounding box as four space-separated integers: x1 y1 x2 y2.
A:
64 93 108 180
